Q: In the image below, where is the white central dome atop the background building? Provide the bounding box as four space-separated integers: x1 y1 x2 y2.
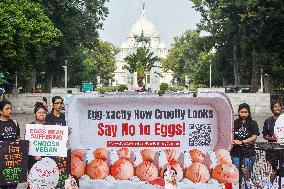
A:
130 9 157 36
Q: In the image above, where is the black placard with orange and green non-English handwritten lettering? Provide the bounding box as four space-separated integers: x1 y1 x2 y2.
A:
0 140 29 185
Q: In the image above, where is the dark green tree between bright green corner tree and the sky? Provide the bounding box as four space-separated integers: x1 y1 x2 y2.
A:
34 0 108 91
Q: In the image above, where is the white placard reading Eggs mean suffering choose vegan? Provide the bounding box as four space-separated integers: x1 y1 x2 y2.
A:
25 124 68 157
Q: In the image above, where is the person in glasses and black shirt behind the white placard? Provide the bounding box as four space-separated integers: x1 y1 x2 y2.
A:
46 96 66 126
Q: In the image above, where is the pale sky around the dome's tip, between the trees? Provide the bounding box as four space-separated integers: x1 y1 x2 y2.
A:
100 0 201 48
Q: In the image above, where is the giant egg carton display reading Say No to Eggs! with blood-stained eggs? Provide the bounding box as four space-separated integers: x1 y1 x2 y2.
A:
67 93 239 189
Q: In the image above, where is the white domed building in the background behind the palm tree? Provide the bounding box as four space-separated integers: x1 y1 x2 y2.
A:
113 6 173 91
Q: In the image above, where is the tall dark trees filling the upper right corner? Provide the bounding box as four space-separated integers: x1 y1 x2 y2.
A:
192 0 284 91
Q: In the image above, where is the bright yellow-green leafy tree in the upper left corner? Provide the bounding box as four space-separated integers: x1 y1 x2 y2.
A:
0 0 61 90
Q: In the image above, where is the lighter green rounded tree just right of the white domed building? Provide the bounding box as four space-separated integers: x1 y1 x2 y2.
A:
162 30 213 86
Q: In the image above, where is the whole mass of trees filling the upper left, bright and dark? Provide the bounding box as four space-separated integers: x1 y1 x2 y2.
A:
0 0 113 91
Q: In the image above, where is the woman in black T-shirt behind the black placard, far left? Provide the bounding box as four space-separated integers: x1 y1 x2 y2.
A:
0 100 20 189
